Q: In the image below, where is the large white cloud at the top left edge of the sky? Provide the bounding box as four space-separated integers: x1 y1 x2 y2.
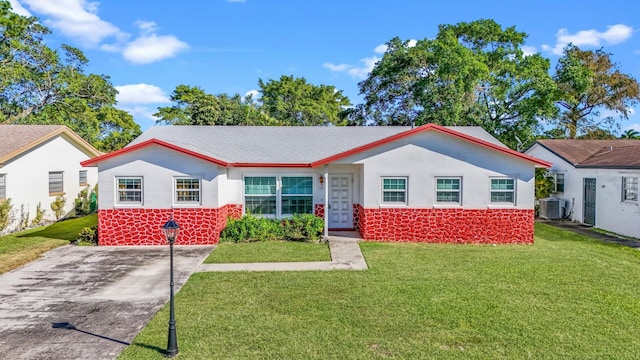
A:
23 0 127 47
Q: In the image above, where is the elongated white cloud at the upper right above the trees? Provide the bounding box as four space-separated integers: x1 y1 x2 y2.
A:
542 24 633 55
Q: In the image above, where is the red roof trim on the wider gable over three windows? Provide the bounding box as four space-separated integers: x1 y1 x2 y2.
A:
311 124 551 168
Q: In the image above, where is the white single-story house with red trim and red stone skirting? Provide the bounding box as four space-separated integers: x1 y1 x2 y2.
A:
82 124 550 245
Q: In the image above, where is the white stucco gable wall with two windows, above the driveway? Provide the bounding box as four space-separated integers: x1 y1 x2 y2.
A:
98 145 219 209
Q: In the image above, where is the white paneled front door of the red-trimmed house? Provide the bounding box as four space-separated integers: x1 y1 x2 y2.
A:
329 175 353 229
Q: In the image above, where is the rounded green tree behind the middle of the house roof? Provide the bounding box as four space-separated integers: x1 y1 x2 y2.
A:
258 75 351 125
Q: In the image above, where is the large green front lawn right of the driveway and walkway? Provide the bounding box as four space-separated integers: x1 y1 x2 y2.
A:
120 224 640 359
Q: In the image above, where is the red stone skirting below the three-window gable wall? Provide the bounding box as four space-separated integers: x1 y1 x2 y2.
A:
353 204 534 244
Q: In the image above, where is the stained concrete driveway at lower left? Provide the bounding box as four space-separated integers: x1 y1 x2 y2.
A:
0 245 213 359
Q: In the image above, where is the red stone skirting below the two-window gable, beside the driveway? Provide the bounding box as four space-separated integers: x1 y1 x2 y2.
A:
98 204 242 245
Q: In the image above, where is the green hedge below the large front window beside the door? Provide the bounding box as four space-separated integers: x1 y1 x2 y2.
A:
220 214 324 243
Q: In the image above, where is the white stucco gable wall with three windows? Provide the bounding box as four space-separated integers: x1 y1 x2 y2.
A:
339 132 535 209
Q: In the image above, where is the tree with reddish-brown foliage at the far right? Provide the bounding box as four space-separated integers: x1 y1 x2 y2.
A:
554 45 640 139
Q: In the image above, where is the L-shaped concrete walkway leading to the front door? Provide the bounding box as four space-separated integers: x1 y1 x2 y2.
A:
196 231 368 272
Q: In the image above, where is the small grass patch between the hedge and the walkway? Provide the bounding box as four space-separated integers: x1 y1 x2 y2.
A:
205 241 331 263
